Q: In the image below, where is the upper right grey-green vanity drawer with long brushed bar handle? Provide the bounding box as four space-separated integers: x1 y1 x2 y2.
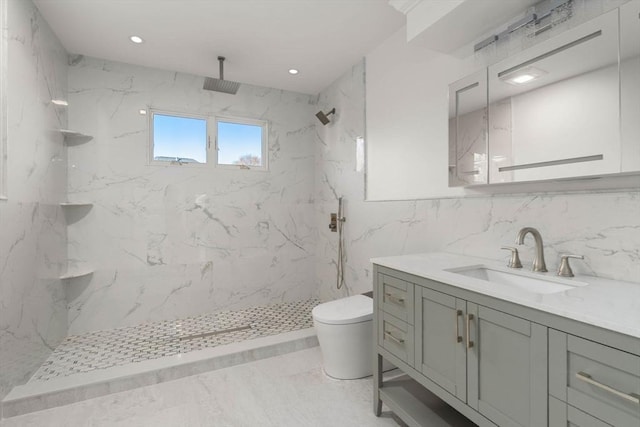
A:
549 332 640 427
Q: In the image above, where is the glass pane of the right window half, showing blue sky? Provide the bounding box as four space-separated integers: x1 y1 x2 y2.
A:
218 122 263 166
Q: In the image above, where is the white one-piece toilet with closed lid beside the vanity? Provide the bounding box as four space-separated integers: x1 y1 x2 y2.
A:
311 295 390 380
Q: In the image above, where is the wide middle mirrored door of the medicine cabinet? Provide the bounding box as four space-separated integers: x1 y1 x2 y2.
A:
484 9 620 183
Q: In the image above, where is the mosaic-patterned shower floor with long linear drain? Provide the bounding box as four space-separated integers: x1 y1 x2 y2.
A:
31 299 319 381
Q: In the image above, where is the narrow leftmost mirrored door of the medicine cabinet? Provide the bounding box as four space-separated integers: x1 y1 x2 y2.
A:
449 69 488 187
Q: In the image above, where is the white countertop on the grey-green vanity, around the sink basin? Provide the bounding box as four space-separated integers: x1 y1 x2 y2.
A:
371 252 640 338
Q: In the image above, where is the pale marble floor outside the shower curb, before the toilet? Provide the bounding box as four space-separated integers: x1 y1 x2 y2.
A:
0 347 410 427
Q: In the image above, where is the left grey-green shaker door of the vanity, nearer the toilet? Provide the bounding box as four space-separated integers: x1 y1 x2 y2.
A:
415 287 467 402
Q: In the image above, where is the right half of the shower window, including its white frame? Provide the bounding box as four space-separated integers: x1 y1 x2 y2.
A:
215 117 268 170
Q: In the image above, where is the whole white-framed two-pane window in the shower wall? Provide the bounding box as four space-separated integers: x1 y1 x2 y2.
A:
149 109 268 171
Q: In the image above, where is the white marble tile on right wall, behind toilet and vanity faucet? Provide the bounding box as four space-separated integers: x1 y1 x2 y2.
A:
316 58 640 300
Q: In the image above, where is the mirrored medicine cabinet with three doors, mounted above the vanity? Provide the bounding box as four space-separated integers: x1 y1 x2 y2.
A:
449 1 640 187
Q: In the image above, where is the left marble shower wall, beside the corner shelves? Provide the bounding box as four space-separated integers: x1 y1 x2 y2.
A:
0 0 67 404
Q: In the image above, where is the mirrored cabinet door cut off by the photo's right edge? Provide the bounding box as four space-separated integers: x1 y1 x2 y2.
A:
620 0 640 172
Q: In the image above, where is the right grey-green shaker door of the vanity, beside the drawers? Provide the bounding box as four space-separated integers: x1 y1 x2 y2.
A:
467 302 548 427
